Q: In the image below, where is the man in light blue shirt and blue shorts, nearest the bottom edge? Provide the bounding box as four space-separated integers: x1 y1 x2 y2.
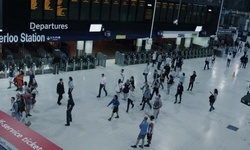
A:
131 117 148 148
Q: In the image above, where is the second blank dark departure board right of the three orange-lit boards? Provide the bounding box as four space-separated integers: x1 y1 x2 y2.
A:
80 0 90 21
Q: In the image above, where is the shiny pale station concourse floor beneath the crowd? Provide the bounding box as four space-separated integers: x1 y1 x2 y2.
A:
0 54 250 150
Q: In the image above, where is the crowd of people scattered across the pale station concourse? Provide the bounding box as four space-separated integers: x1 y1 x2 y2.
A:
5 42 248 148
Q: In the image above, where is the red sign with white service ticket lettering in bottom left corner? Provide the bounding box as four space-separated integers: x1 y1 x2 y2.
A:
0 111 62 150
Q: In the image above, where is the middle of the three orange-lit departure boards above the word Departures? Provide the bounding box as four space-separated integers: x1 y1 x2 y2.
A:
44 0 56 20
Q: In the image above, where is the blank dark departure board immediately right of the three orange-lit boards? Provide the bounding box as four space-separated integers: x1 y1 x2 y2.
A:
68 0 80 20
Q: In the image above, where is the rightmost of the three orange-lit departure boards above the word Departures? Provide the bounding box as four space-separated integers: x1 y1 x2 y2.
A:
56 0 68 20
